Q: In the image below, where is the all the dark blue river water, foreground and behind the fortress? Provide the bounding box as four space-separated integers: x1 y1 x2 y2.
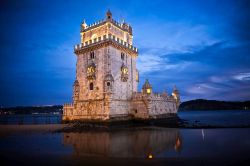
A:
0 111 250 166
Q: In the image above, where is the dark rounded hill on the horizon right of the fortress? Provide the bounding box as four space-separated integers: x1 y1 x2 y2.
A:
179 99 250 111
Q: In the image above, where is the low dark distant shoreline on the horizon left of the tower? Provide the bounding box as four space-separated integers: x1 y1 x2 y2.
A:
0 105 63 114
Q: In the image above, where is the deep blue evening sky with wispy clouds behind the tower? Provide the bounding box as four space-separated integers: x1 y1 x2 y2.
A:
0 0 250 106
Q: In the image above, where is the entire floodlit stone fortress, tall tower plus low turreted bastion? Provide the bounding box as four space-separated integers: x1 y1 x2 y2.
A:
63 11 180 121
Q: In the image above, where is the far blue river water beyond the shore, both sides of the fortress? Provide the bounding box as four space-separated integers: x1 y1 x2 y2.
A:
0 111 250 126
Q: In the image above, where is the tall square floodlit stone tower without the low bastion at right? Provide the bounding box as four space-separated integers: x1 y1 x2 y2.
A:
64 11 139 120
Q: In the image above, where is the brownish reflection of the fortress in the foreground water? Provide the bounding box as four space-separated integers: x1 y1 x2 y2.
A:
63 129 182 159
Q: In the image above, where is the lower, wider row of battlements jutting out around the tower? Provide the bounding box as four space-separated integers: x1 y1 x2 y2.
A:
74 34 138 54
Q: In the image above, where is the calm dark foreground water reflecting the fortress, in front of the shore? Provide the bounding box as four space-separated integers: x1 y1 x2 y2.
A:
0 128 250 163
